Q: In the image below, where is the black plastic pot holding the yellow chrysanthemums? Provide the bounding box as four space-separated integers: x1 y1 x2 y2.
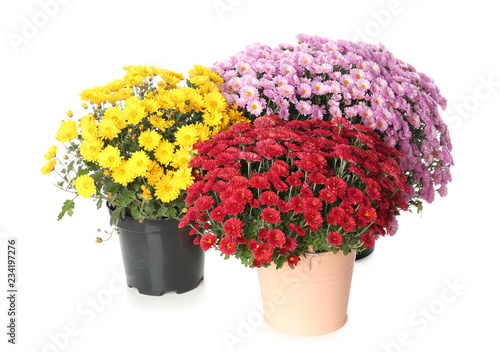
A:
112 210 205 296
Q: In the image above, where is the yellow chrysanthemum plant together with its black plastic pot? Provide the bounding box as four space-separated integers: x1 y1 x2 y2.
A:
42 65 248 295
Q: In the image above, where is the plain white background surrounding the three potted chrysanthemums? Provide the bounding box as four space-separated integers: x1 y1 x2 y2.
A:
0 0 500 352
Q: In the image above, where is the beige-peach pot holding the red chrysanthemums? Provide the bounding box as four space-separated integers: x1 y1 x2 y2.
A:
257 251 356 336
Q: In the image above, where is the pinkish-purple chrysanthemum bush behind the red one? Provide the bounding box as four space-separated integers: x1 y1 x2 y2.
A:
213 35 453 209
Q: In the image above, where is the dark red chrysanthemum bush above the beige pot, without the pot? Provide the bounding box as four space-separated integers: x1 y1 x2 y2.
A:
180 115 407 268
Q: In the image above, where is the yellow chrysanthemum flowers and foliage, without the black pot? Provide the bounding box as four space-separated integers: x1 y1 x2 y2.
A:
42 65 246 224
